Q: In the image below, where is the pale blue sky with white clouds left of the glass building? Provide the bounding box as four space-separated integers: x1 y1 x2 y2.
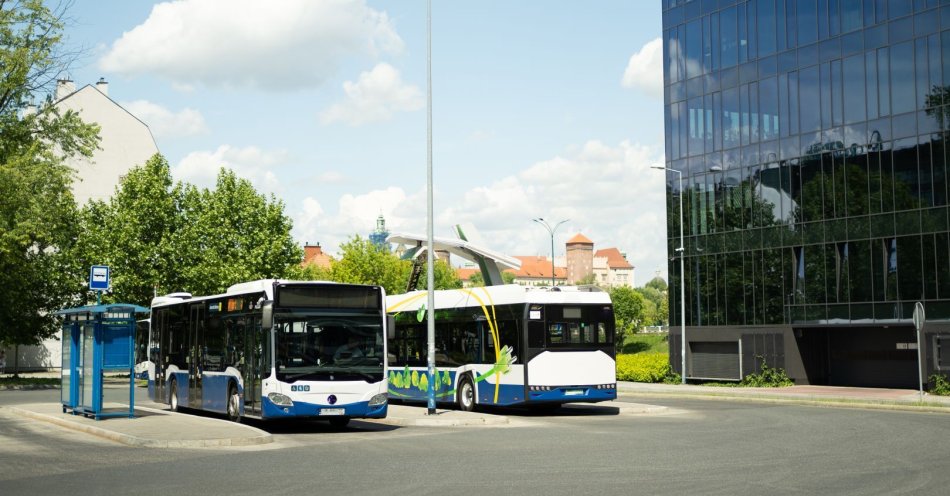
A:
64 0 667 285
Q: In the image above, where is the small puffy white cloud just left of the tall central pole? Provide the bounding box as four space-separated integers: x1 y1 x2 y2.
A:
320 63 425 126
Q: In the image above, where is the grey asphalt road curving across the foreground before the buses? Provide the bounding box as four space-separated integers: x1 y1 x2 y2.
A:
0 391 950 496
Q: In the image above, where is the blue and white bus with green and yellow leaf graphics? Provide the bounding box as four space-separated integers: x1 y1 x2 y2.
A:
386 285 617 410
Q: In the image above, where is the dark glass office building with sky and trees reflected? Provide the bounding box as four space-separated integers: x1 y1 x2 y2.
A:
662 0 950 388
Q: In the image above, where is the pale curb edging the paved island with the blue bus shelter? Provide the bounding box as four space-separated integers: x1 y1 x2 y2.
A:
0 406 274 448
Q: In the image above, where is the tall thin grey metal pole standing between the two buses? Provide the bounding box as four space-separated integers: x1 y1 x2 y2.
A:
426 0 435 415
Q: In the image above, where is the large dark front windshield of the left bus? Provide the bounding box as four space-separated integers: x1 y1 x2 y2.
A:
274 314 385 383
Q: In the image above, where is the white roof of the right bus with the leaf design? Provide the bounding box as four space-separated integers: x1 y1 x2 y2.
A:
386 284 610 312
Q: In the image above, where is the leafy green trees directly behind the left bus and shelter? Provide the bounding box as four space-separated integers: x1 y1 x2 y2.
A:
77 155 301 305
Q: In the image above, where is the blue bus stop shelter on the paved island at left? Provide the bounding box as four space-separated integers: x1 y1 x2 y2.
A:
55 303 149 420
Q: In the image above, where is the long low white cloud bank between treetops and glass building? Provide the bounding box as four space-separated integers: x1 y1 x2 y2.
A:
295 141 667 285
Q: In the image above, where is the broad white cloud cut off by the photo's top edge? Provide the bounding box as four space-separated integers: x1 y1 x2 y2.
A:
99 0 403 90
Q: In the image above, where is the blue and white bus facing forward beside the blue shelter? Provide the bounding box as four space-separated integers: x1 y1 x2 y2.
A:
149 279 388 427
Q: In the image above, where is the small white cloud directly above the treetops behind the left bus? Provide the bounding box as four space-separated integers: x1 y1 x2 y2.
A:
172 145 288 193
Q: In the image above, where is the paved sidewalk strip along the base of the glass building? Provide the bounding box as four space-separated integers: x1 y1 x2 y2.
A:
617 382 950 413
